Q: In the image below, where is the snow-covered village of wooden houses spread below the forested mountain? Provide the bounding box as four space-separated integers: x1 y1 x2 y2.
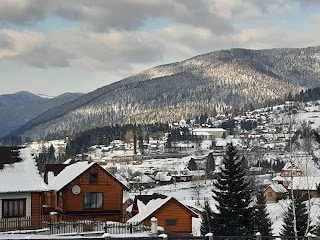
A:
0 102 320 236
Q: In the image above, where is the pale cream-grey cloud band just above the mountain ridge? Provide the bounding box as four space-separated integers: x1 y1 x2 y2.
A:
0 22 320 76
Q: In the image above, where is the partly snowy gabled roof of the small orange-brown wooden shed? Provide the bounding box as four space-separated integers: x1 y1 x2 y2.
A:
127 194 198 223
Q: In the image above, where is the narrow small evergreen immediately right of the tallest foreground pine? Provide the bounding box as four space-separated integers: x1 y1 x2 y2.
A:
254 192 272 236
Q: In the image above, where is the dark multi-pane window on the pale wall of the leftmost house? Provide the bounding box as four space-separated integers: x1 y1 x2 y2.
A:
2 198 26 218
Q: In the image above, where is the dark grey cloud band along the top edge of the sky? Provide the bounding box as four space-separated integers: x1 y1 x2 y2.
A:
0 0 233 32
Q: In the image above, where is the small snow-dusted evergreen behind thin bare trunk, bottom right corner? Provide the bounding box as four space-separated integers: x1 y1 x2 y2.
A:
281 198 314 236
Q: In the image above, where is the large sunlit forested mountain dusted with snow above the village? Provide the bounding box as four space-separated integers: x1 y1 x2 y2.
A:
6 46 320 142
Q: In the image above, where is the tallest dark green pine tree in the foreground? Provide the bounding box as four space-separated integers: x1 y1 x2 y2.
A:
213 144 254 236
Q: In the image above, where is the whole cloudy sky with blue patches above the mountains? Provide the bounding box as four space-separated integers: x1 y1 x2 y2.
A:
0 0 320 96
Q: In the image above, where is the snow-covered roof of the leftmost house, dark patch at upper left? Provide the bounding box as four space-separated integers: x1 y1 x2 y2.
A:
0 148 48 193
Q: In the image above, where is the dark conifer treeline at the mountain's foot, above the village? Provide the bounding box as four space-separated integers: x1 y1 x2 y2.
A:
66 123 169 158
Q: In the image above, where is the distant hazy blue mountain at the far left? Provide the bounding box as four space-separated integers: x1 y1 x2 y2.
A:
0 91 83 137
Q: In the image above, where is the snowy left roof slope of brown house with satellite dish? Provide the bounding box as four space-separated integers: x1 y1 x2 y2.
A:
48 162 95 191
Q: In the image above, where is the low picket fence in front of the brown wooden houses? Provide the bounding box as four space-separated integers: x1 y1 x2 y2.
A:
0 217 150 234
